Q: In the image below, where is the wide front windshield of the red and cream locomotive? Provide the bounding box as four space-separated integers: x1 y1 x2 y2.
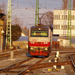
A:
31 31 48 37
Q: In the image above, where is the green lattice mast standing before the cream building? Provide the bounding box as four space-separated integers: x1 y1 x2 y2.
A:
67 0 71 46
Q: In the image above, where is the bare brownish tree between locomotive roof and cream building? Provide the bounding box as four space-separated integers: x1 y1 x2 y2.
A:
41 11 53 30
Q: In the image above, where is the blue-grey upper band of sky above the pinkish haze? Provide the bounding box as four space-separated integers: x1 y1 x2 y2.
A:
0 0 62 9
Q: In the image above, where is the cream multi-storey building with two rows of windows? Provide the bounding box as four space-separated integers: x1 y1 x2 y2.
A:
53 10 75 36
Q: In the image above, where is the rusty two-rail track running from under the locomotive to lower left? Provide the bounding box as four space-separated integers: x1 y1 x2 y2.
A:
0 57 46 74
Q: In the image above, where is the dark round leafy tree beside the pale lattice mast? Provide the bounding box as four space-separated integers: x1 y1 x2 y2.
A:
11 24 22 41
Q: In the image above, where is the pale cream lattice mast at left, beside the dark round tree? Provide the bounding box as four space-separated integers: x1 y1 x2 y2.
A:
6 0 11 48
